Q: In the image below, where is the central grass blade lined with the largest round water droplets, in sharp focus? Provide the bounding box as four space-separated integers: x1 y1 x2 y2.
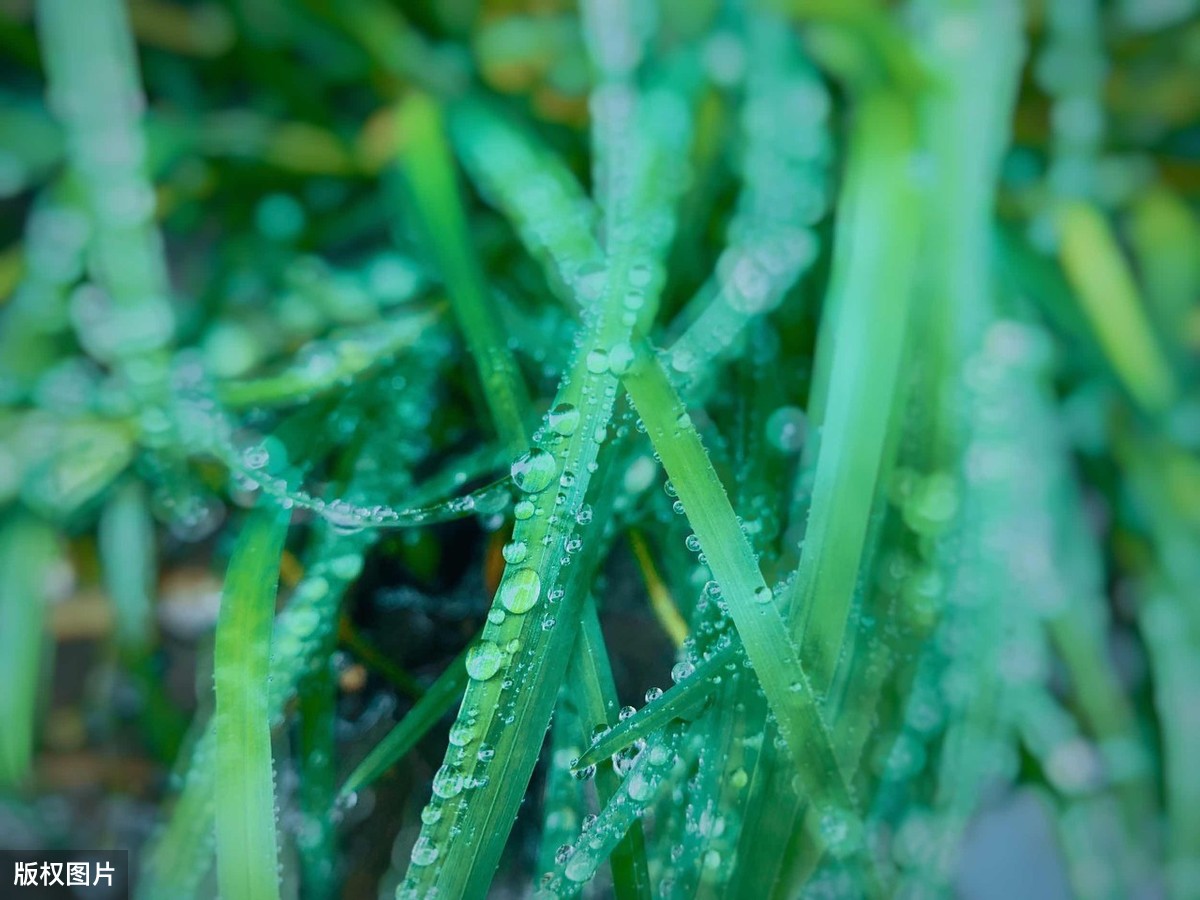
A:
397 14 690 898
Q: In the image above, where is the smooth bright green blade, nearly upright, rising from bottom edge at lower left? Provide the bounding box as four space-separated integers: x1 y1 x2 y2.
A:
212 506 290 900
